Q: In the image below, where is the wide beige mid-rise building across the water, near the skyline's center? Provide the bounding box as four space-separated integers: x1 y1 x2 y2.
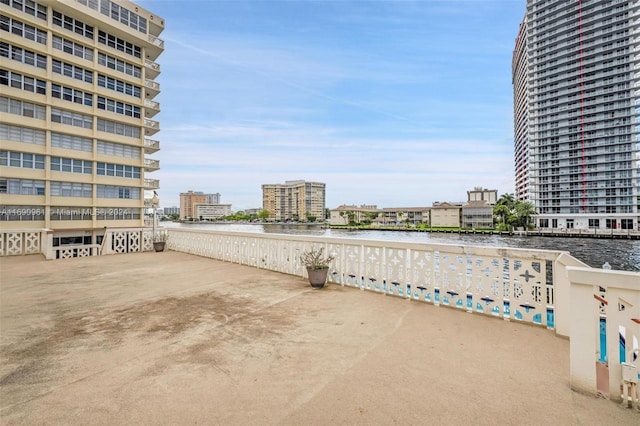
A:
262 180 325 221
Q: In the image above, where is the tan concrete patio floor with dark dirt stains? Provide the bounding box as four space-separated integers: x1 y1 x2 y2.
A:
0 251 640 425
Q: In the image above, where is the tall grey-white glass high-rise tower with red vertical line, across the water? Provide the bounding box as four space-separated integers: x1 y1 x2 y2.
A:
512 0 640 230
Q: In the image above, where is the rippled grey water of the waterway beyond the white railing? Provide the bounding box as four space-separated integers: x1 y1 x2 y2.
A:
163 222 640 271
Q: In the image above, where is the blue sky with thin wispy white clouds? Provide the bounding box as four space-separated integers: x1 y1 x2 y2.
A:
138 0 526 211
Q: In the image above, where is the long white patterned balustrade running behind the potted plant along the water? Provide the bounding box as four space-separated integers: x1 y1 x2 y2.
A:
168 228 580 332
